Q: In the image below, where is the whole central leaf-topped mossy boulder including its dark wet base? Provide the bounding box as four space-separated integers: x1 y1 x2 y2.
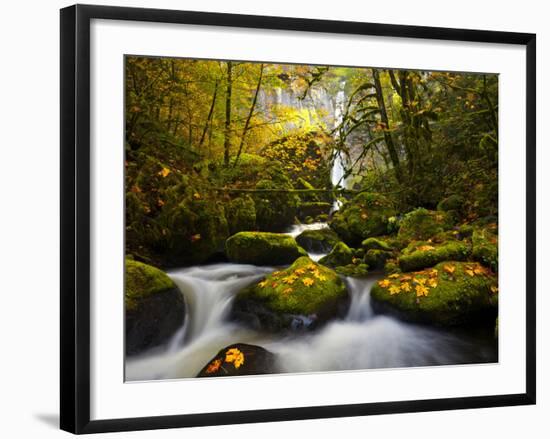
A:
232 256 349 332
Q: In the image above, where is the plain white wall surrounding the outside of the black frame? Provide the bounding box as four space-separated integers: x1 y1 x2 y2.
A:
0 0 550 438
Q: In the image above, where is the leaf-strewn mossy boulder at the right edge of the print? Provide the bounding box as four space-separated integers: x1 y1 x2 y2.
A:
371 261 498 326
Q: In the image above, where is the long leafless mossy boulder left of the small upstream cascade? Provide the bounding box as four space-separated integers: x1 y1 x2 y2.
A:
225 232 307 265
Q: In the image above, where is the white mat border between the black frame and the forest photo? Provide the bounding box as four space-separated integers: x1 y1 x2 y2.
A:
91 20 525 419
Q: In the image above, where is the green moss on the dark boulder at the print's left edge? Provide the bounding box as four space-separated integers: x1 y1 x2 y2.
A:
124 258 176 310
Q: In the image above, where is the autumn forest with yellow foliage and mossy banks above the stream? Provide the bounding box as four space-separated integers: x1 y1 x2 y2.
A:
125 56 498 266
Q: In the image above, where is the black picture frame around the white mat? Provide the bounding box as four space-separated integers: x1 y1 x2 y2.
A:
60 5 536 434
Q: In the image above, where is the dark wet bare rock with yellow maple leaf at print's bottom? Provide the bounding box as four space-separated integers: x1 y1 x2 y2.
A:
197 343 278 378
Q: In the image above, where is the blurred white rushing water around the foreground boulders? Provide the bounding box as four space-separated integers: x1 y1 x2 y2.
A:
126 263 496 380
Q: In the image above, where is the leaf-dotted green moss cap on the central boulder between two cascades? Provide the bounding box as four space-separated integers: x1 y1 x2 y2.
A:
236 256 348 316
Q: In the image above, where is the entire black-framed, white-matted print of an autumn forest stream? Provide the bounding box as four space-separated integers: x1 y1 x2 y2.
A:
61 5 536 433
